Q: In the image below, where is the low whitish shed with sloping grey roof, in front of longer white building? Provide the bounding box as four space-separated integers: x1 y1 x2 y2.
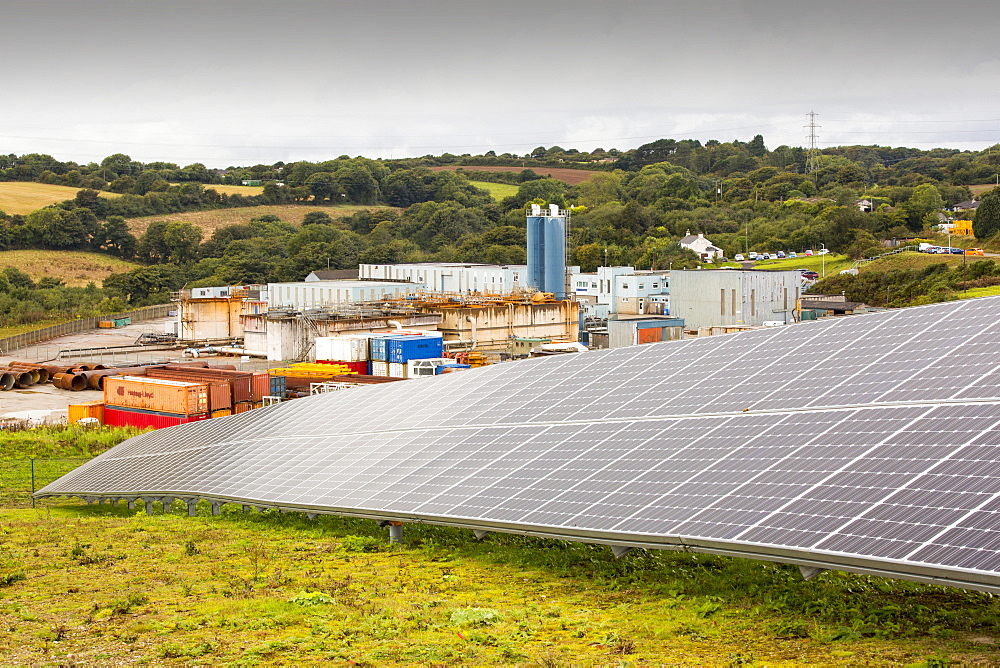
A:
267 280 424 310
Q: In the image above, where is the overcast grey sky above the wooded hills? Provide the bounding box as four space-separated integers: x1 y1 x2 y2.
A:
0 0 1000 167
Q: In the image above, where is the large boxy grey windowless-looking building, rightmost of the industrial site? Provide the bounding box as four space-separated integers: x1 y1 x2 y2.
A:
670 269 802 330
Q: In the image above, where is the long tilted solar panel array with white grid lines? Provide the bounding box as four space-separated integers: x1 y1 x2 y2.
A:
39 298 1000 591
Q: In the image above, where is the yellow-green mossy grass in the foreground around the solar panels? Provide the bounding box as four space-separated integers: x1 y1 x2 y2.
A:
0 427 1000 668
